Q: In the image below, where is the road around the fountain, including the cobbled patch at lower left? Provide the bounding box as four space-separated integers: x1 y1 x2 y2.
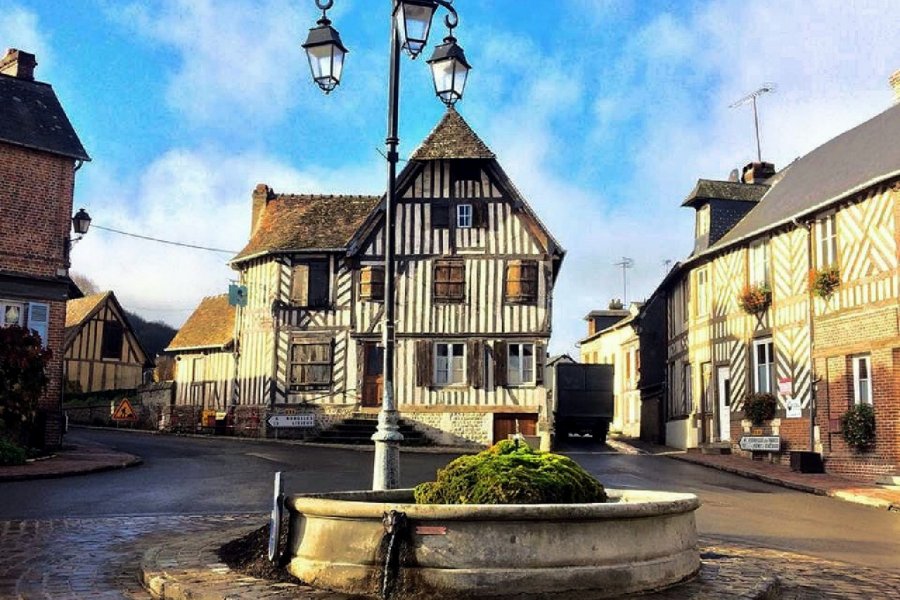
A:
0 430 900 599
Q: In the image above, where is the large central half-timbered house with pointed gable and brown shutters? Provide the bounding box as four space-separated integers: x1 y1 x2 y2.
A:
171 108 564 443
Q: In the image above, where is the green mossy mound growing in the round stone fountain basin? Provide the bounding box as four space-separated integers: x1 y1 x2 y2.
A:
414 440 607 504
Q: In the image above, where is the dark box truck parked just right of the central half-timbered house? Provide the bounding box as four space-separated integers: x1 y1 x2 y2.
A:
547 361 614 444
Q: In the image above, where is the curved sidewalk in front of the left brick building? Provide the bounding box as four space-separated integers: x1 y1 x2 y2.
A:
0 444 141 482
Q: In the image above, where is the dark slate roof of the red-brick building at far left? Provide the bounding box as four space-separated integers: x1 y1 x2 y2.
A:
0 75 91 160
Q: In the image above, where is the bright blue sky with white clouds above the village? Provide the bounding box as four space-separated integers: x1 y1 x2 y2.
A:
0 0 900 355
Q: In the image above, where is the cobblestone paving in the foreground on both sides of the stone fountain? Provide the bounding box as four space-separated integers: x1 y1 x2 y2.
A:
0 514 900 600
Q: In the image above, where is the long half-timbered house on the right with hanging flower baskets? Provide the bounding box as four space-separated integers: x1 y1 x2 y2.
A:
661 83 900 477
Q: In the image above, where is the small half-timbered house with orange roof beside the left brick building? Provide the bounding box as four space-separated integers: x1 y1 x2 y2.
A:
64 291 152 393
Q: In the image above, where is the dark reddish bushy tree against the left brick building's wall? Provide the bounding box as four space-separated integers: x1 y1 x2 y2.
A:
0 326 52 445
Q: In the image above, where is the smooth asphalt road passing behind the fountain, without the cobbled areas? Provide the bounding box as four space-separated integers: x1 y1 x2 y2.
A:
0 429 900 572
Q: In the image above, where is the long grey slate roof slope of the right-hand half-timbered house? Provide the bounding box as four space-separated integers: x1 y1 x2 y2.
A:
704 104 900 254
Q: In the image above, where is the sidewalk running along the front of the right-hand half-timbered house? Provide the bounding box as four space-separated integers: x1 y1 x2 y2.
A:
610 439 900 511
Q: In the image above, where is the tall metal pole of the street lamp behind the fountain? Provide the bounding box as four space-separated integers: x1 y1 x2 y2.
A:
372 2 403 490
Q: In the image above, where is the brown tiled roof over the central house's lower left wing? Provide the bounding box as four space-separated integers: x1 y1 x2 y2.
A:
232 194 381 262
